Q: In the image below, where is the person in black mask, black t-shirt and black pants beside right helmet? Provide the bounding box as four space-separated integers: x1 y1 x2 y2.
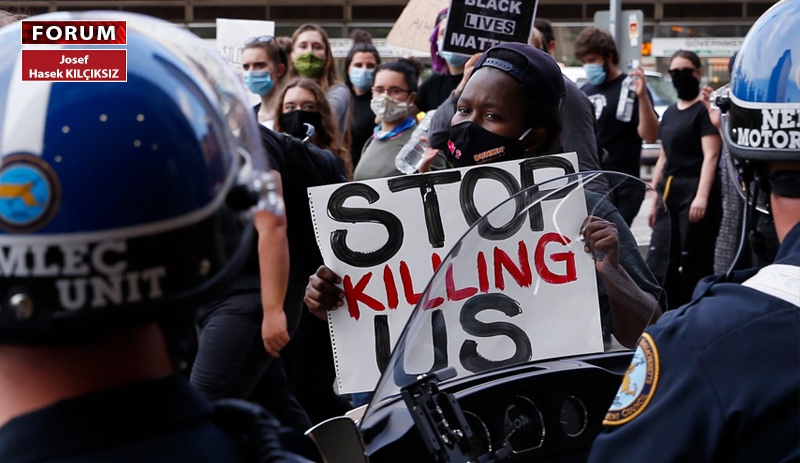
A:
648 50 722 307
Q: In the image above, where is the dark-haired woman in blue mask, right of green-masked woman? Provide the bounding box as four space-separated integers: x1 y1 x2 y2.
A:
344 42 381 166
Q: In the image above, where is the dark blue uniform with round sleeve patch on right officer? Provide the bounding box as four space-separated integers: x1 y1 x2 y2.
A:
589 224 800 463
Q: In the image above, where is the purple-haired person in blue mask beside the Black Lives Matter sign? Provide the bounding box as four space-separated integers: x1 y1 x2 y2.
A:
416 8 469 111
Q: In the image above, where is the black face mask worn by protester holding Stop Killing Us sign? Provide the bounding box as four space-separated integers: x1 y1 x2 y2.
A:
447 122 530 167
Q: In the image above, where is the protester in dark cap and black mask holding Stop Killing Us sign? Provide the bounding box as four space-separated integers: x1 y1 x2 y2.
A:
305 43 663 360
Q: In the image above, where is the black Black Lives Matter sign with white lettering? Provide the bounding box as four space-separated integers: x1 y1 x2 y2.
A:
444 0 539 55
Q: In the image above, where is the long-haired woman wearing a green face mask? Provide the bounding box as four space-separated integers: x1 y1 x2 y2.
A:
292 23 350 143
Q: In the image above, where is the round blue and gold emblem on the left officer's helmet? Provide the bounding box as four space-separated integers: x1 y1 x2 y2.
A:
0 154 61 233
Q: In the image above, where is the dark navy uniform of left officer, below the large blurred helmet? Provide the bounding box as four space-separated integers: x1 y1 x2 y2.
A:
0 376 245 463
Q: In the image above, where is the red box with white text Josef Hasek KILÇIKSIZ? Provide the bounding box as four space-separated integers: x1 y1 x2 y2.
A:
22 50 128 82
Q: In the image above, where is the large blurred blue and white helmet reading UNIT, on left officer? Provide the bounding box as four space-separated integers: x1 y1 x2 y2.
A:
0 12 282 343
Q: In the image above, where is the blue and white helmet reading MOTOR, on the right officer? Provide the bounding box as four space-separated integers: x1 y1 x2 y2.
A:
724 0 800 161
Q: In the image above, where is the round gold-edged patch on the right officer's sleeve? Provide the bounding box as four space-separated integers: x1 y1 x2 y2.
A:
603 333 659 426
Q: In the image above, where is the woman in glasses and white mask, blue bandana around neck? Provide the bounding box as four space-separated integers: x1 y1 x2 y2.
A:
353 59 445 180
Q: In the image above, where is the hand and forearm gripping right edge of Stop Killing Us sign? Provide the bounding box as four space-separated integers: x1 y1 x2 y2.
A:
582 216 662 347
